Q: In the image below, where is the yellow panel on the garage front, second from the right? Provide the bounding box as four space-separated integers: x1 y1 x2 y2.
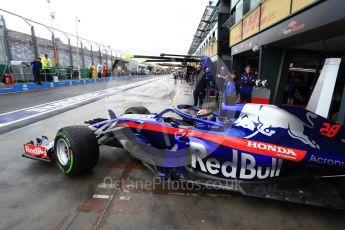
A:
260 0 291 30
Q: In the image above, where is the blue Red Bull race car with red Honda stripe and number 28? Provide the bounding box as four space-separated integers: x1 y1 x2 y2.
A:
23 57 345 209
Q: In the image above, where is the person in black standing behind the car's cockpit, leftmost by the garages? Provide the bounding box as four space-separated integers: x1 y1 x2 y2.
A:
193 64 209 108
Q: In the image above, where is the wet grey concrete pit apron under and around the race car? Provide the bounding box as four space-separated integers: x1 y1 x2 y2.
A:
0 78 345 229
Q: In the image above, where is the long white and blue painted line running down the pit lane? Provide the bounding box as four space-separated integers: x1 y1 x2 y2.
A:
0 77 163 128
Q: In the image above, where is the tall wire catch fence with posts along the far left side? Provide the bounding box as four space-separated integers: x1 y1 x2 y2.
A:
0 9 123 81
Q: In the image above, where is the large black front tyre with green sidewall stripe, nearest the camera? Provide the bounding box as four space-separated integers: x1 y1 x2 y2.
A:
54 126 99 176
